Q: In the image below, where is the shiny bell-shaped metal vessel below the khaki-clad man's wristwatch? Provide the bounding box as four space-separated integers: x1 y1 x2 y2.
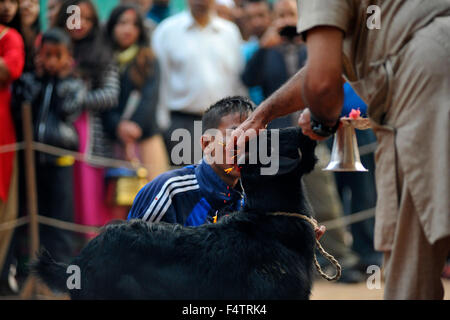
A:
323 118 368 172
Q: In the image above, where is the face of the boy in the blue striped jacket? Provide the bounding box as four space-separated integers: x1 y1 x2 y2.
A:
202 112 250 178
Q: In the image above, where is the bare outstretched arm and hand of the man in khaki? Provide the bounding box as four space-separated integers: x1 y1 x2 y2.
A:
227 26 343 151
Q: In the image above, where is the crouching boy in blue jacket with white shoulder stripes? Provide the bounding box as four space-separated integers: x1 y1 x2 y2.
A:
128 97 253 226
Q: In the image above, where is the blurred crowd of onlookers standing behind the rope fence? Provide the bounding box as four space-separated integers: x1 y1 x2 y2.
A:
0 0 394 294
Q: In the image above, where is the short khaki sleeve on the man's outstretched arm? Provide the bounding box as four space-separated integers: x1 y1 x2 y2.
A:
297 0 352 33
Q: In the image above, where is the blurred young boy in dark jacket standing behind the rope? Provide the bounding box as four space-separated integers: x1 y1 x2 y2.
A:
16 29 85 262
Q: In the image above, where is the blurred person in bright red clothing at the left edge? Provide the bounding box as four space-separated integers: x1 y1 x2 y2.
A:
0 19 25 295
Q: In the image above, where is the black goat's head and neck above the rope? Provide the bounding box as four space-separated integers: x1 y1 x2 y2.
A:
239 128 317 212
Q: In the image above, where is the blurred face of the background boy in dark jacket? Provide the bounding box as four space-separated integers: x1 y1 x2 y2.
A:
39 42 71 76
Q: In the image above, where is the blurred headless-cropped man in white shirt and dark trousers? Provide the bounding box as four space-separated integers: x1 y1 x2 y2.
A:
152 0 246 164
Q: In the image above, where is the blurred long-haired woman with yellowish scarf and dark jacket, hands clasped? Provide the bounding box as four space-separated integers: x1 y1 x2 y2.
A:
103 5 169 219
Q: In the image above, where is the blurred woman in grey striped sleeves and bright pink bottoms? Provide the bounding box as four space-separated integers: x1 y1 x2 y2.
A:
57 0 120 235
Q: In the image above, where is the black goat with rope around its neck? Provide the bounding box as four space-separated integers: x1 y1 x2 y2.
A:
32 128 316 300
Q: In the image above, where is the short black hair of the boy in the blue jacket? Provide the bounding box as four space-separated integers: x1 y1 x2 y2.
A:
202 96 255 133
